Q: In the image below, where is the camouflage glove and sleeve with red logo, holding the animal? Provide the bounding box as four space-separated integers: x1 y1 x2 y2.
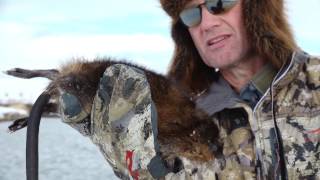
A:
90 64 221 180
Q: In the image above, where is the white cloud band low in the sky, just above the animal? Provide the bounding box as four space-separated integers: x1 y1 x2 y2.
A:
0 23 173 72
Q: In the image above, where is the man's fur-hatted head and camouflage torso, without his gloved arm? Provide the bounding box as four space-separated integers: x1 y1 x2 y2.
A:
161 0 320 179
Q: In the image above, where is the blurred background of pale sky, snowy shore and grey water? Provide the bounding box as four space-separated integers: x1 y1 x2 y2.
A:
0 0 320 180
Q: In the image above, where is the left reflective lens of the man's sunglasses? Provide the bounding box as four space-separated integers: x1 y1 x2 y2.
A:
180 7 201 27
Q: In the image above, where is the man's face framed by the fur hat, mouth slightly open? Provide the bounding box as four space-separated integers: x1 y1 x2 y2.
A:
187 0 250 69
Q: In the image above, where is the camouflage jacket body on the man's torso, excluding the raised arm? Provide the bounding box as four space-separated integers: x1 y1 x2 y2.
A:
185 52 320 180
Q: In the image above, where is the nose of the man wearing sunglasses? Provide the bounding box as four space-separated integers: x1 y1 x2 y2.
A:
200 5 221 31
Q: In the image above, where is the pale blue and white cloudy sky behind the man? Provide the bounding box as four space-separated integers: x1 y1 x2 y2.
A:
0 0 320 101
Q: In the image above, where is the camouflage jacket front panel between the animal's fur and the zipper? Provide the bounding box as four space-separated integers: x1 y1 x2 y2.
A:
215 106 256 180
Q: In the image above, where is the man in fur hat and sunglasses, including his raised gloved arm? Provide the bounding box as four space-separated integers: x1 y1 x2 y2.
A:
24 0 320 180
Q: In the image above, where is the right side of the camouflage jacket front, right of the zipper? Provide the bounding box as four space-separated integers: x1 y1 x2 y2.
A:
251 52 320 180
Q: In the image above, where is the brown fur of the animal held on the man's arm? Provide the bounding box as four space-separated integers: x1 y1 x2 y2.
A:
44 59 218 161
